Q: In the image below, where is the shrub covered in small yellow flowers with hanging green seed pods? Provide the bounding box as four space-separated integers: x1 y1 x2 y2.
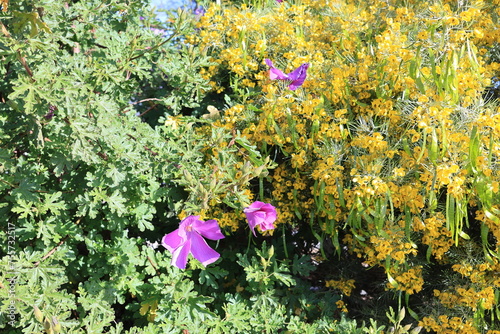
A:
188 0 500 333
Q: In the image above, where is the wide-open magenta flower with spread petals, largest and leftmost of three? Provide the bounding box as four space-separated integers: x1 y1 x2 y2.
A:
161 216 224 269
